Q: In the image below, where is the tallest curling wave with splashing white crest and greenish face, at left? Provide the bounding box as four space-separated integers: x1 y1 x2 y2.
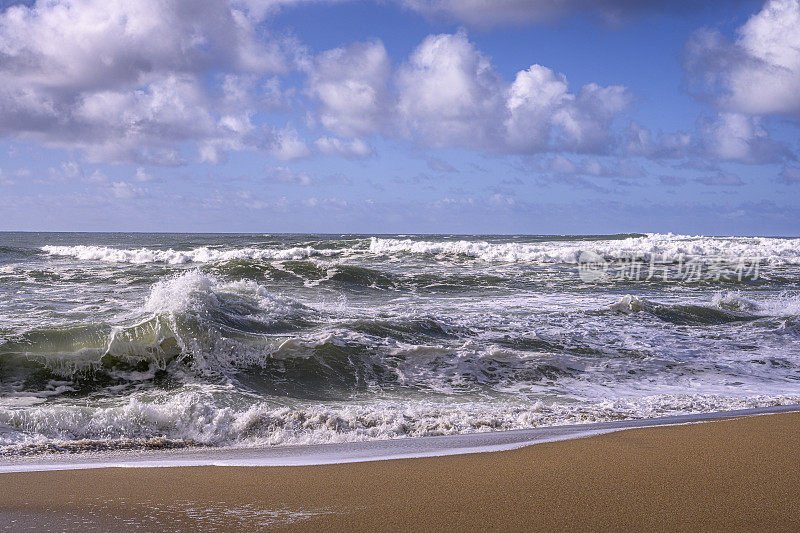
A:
0 271 314 395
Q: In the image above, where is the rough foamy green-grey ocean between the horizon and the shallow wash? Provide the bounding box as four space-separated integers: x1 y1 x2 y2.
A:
0 233 800 456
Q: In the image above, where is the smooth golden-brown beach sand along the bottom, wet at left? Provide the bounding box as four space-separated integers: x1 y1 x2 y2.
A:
0 413 800 531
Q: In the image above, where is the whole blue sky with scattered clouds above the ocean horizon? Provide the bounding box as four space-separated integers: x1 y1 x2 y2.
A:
0 0 800 236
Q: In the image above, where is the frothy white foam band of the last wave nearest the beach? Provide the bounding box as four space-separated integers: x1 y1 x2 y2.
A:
0 385 800 448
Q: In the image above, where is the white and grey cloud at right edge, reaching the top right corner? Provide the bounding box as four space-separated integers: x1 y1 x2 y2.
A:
625 0 800 166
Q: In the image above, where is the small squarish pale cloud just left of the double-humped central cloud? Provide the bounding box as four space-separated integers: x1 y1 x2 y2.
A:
308 41 391 137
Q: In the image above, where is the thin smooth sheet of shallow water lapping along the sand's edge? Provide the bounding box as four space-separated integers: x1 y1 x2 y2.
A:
0 404 800 474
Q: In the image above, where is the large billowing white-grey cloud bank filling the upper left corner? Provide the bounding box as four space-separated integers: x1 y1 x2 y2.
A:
0 0 296 164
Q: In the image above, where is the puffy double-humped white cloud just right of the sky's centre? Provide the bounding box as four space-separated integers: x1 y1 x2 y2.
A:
397 33 629 153
